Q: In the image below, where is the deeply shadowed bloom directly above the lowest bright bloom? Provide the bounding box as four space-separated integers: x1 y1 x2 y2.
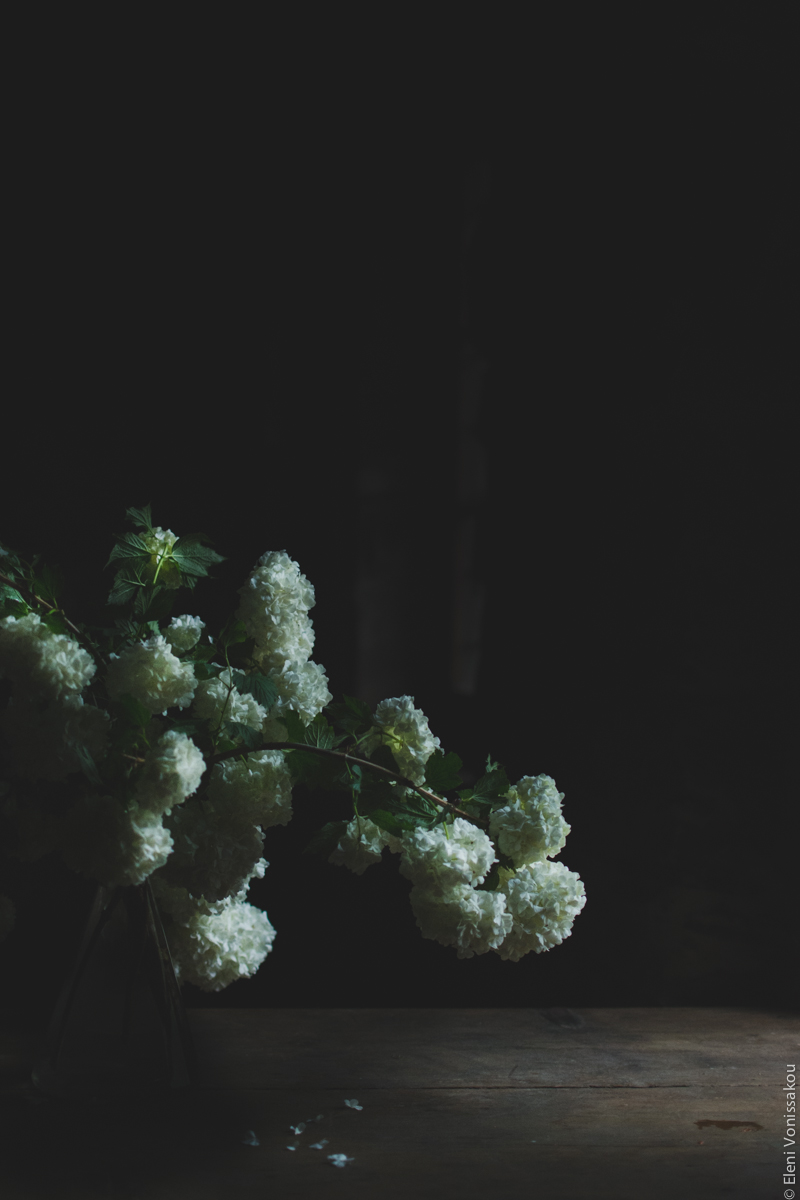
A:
163 798 264 900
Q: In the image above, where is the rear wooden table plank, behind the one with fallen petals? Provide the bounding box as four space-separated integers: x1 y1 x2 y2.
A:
184 1009 800 1088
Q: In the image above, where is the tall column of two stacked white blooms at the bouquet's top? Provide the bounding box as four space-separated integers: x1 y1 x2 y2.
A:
236 550 333 720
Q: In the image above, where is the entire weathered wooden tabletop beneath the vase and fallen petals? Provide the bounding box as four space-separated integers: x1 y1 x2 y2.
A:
0 1008 800 1200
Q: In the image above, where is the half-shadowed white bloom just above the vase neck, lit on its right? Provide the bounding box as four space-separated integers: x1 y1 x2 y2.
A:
59 793 173 887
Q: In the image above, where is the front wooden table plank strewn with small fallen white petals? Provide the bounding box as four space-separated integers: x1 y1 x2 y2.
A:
2 1088 782 1200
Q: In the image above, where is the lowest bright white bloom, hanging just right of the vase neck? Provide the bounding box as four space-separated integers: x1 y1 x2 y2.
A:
152 858 275 991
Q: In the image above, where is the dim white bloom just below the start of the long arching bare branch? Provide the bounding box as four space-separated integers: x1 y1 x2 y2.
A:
206 750 291 829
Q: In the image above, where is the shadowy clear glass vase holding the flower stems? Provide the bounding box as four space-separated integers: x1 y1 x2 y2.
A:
31 880 194 1098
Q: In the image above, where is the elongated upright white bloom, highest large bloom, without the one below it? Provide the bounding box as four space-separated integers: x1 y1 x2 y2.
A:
236 550 314 670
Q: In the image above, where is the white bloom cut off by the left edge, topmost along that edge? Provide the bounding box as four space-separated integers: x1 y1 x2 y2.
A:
0 612 97 700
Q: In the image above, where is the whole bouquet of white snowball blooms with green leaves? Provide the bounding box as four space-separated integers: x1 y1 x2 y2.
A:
0 505 585 991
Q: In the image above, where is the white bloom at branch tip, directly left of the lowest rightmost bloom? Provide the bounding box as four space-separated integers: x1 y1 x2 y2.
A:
410 883 511 959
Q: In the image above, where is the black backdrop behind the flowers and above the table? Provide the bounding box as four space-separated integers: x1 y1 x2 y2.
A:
1 5 798 1013
